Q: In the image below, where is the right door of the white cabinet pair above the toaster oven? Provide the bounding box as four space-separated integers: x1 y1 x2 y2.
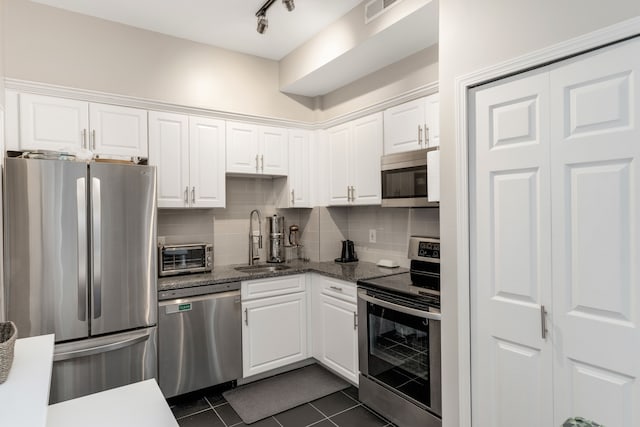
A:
189 117 226 208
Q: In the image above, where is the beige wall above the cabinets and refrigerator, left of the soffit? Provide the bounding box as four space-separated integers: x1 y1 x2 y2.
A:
4 0 313 122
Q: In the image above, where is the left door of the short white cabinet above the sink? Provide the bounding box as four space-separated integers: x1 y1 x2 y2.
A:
226 122 260 174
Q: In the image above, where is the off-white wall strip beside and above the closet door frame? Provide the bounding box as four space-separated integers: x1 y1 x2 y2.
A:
439 0 640 427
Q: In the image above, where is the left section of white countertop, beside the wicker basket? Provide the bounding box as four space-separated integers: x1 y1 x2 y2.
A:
0 334 54 427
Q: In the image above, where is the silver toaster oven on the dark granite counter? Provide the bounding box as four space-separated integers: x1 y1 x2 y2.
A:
158 243 213 277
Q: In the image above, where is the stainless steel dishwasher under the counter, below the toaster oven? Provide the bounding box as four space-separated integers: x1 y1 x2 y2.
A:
158 282 242 398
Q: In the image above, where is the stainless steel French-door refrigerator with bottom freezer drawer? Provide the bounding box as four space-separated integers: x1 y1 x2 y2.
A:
4 158 157 403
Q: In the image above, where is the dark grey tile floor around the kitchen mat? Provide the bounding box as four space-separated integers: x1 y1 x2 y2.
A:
169 386 393 427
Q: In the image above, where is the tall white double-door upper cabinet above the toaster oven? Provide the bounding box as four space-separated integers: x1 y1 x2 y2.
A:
149 111 225 208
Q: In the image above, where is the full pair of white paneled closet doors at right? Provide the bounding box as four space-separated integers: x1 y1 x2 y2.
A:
470 39 640 427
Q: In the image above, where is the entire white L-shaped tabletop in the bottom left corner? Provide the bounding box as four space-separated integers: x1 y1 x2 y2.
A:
0 335 178 427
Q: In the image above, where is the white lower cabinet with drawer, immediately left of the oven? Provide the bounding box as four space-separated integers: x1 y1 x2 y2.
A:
311 274 358 384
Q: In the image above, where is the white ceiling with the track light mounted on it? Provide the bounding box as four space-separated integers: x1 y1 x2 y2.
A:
33 0 362 60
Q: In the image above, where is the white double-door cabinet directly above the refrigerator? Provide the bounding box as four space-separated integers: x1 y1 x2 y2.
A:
15 93 148 158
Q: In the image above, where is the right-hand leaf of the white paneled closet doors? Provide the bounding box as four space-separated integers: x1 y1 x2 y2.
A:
550 39 640 427
